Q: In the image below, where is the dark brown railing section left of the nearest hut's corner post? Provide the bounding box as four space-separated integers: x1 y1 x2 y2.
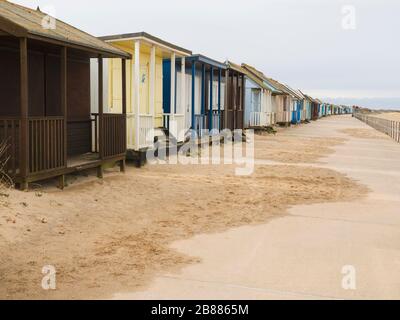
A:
0 118 21 176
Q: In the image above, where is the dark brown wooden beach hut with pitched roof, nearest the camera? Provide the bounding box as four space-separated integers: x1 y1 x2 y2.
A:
0 1 130 189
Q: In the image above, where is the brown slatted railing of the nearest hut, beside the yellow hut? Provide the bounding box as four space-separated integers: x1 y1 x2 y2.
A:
92 113 126 159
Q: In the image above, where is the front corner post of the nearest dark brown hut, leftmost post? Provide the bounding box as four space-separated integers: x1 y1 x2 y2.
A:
19 38 29 190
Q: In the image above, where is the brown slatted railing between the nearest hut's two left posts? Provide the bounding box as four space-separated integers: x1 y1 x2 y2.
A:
28 117 66 174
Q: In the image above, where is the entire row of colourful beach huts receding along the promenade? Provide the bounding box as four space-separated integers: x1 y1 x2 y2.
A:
0 1 352 189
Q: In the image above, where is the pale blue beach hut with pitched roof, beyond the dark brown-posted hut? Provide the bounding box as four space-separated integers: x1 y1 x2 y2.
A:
242 64 275 128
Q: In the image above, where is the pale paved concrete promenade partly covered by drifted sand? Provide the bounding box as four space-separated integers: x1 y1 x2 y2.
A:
114 116 400 299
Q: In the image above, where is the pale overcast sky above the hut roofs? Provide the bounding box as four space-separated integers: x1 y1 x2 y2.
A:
7 0 400 109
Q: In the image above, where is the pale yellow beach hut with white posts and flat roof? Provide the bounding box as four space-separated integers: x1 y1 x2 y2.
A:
93 32 192 159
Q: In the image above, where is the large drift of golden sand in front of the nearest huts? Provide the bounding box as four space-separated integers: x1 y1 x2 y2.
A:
0 123 368 299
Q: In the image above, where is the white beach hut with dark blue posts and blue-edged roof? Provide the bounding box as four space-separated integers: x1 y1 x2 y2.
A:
163 54 226 142
